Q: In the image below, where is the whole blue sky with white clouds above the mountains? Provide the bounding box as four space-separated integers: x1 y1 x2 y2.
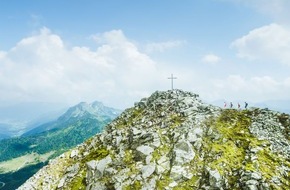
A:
0 0 290 108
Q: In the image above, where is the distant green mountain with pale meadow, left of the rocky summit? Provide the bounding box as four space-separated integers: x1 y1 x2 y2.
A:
0 103 120 189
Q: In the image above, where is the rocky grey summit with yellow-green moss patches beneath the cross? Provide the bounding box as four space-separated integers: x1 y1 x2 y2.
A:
19 90 290 190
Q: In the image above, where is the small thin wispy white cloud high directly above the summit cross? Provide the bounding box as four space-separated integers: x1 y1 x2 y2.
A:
145 40 186 53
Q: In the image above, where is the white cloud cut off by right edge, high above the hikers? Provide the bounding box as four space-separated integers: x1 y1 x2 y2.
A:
231 23 290 65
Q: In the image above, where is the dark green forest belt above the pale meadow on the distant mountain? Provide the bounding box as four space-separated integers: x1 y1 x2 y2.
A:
0 117 109 162
